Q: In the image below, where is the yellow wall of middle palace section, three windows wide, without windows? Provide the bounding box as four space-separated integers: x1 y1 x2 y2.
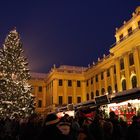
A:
47 69 84 104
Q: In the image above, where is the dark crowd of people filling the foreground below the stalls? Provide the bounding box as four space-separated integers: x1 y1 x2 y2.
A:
0 108 140 140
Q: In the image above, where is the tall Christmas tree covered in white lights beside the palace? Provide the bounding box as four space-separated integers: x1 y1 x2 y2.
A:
0 29 34 118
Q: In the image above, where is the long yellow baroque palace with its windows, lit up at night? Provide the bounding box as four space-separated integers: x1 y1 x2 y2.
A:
30 7 140 113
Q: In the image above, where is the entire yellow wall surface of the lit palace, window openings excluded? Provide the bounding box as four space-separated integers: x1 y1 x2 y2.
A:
30 8 140 114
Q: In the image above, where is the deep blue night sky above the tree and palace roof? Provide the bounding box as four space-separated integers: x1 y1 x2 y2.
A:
0 0 140 73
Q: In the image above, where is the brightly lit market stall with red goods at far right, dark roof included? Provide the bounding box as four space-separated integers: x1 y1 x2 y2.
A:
108 88 140 124
